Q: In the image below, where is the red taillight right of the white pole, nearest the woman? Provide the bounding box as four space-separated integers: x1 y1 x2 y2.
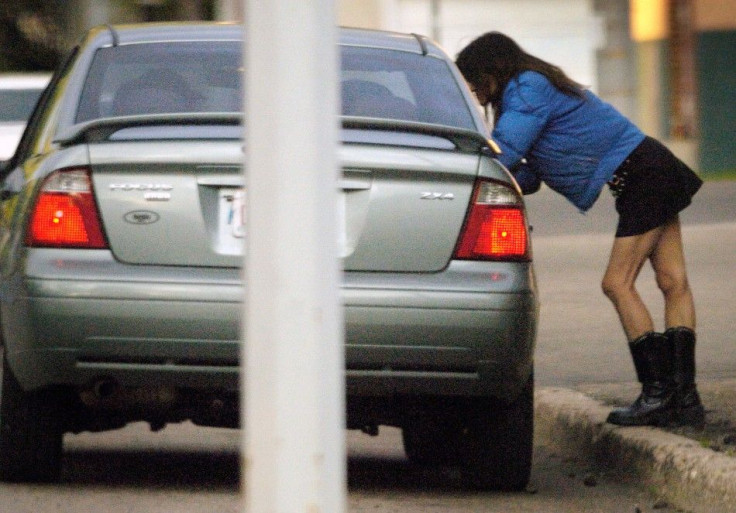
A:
454 180 529 260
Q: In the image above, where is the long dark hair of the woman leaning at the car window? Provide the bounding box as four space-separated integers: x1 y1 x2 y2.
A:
456 32 585 114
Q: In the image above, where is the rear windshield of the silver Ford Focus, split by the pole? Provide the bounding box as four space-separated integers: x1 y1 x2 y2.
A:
76 41 475 129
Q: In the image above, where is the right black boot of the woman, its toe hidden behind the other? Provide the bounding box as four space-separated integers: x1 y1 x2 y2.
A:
664 326 705 426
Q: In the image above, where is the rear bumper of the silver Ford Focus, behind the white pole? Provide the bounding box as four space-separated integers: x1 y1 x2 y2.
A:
0 250 538 398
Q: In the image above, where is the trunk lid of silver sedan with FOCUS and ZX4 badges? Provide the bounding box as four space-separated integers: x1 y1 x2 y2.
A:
89 136 478 272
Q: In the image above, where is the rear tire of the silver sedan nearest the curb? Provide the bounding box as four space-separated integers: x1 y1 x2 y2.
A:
458 375 534 490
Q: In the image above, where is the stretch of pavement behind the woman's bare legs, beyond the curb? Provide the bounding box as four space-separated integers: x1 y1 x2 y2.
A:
527 182 736 386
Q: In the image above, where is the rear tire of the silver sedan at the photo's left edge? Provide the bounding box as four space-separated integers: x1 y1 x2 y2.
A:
0 356 64 483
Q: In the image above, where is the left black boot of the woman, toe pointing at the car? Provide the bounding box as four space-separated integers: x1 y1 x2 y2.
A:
608 332 675 426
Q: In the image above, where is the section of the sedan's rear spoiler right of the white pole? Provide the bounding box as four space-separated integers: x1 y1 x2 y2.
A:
341 116 501 155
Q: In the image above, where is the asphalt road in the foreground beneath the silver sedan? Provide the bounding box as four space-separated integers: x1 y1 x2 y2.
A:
0 423 673 513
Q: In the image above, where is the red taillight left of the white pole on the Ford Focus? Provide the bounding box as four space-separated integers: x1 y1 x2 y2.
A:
26 168 107 248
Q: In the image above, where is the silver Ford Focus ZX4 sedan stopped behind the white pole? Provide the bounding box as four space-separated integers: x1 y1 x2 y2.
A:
0 24 538 489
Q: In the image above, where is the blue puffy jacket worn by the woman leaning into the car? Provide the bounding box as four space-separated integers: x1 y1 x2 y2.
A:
493 71 644 211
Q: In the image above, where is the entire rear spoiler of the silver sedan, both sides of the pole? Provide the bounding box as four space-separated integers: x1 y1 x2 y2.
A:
54 112 501 155
